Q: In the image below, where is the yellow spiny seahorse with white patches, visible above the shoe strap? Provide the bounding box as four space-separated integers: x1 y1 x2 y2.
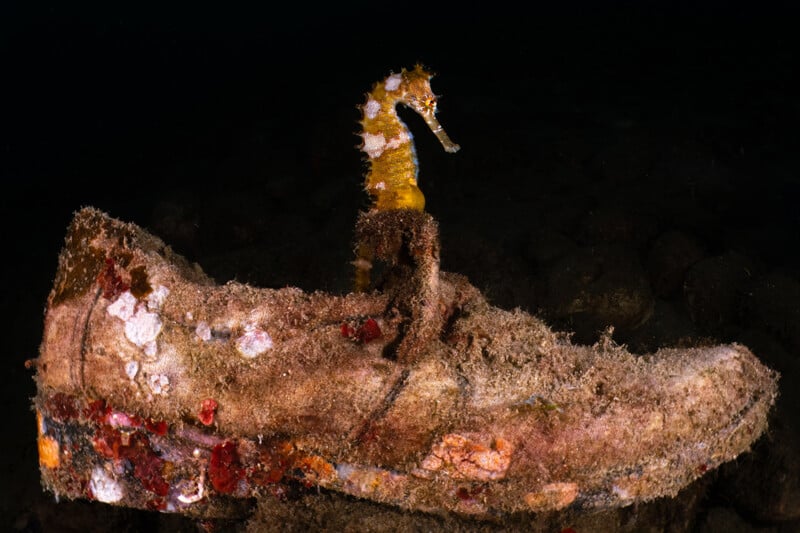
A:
361 65 459 211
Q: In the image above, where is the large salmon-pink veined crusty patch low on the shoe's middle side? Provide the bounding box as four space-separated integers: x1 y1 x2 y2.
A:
420 433 512 481
